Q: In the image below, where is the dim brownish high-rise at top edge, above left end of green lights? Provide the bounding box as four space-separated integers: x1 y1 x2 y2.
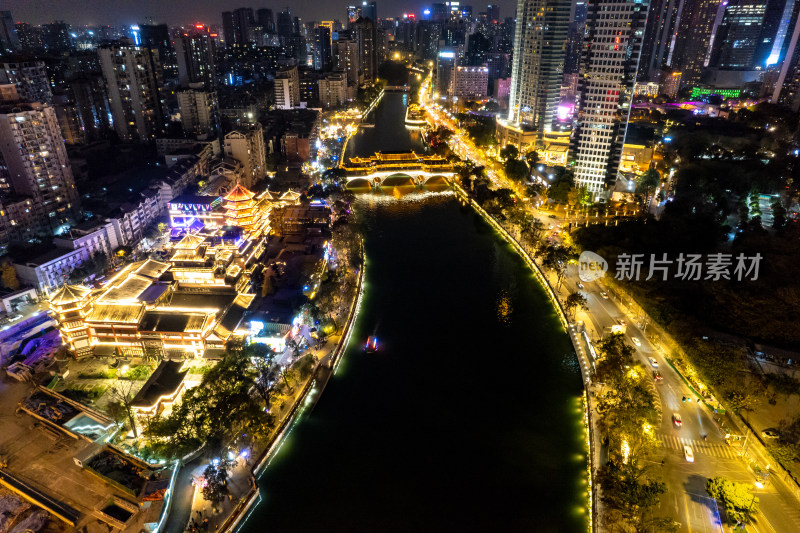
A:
667 0 722 85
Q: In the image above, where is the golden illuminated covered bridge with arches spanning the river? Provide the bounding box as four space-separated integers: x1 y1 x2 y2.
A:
340 151 456 187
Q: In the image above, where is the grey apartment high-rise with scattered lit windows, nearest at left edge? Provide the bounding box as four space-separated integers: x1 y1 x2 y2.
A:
0 102 80 234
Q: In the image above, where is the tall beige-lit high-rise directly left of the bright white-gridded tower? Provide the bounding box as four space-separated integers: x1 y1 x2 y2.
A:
508 0 570 132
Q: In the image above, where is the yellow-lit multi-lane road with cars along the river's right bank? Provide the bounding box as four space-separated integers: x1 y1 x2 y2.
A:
420 84 800 533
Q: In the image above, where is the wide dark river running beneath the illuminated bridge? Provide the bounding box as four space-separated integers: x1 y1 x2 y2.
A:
242 93 587 533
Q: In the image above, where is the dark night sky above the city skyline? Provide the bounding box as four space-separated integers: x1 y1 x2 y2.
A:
2 0 516 26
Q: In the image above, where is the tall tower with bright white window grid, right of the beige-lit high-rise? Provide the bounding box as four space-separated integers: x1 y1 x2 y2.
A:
571 0 648 197
